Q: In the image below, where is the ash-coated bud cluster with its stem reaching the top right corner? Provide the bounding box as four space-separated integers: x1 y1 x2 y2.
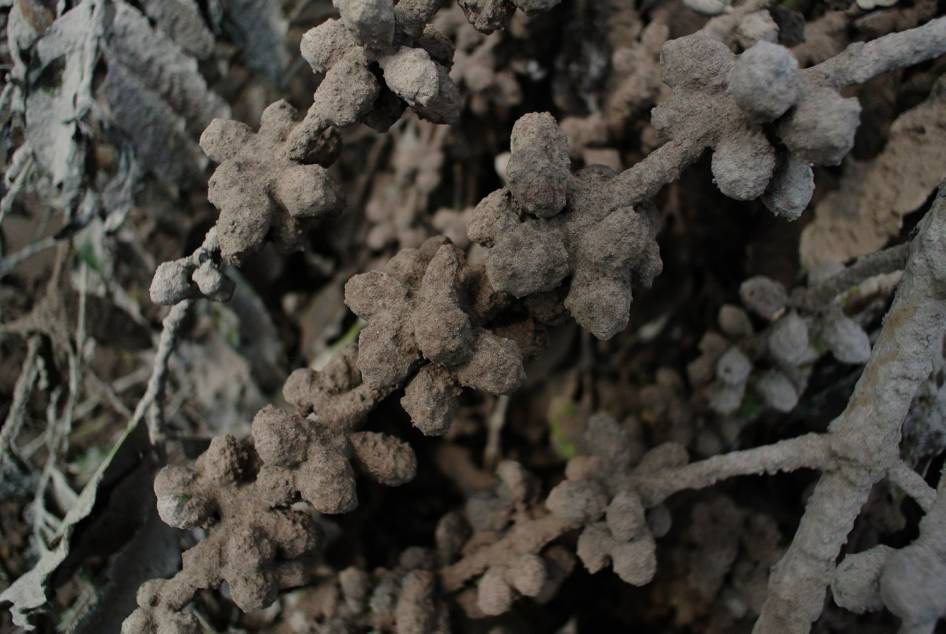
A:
614 21 938 218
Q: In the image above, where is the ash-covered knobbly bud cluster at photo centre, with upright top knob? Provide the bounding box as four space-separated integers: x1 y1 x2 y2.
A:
467 115 662 339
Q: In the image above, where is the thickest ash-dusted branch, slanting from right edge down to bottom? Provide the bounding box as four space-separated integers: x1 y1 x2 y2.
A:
753 188 946 634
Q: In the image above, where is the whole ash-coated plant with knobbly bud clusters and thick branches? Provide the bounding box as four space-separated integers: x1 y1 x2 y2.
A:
1 0 946 634
